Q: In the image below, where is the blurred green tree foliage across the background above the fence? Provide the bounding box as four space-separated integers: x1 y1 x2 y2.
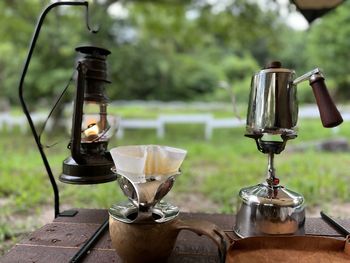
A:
0 0 350 107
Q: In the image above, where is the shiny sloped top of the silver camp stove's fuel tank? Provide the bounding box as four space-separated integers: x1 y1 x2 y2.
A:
239 183 304 207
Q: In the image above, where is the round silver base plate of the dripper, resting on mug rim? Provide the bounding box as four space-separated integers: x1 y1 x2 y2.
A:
109 200 180 224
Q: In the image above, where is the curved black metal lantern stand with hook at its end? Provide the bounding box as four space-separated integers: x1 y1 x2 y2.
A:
18 1 98 218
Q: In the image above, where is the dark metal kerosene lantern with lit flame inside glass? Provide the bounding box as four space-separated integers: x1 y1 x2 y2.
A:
59 46 116 184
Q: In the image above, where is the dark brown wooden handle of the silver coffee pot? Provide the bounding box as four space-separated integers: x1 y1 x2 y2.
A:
310 74 343 128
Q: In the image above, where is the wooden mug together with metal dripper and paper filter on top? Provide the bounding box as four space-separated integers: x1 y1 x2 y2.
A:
109 145 229 263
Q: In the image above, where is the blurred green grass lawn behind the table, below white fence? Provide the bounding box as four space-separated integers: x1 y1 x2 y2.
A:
0 105 350 256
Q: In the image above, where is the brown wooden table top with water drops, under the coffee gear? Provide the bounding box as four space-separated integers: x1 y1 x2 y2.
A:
0 209 350 263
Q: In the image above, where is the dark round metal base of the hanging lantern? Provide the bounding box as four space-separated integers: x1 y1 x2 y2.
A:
59 157 117 184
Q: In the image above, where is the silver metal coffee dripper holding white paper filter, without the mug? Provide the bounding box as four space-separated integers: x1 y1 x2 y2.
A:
109 145 187 224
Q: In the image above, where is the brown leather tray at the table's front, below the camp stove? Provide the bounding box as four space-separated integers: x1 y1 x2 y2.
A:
226 236 350 263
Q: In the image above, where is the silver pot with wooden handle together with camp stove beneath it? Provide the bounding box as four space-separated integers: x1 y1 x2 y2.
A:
234 61 343 237
